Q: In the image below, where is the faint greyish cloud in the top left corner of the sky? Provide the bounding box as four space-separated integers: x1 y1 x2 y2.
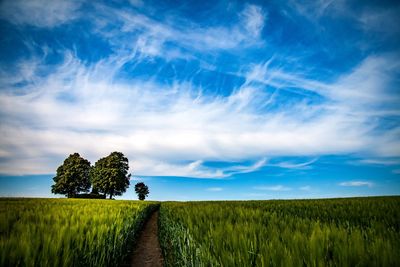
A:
0 0 81 28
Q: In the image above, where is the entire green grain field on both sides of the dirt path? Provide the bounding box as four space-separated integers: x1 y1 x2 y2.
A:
0 197 400 267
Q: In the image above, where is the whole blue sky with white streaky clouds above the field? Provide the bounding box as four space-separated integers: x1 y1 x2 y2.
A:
0 0 400 201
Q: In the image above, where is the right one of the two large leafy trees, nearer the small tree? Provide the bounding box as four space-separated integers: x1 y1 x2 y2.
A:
90 152 131 199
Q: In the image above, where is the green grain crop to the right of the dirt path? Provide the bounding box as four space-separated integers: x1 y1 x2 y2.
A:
160 197 400 267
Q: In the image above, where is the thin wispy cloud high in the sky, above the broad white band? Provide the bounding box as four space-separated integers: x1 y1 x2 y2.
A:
92 4 266 60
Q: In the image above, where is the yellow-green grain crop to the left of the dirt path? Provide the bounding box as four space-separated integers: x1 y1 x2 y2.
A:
0 199 158 267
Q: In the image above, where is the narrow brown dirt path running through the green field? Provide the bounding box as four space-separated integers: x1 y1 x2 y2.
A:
131 210 163 267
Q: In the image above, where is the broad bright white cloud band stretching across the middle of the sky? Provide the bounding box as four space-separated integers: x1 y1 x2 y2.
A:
0 43 400 178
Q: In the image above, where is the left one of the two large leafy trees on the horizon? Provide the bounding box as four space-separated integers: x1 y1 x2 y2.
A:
51 153 90 197
